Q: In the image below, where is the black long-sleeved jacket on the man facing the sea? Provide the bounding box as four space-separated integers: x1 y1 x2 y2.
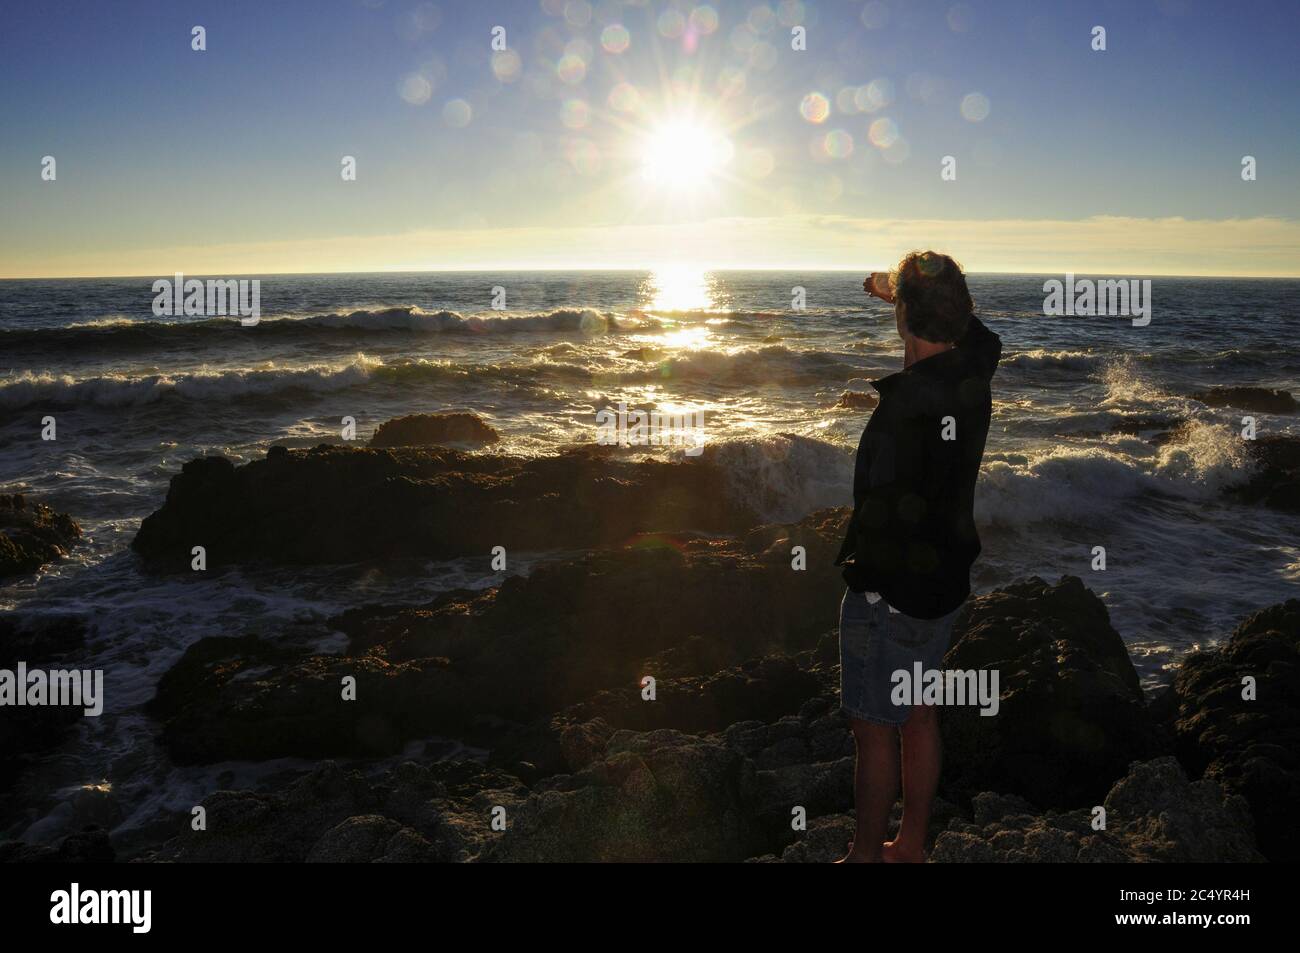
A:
835 317 1002 619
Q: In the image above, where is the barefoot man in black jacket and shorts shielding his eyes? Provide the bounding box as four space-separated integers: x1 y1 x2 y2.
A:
836 251 1002 863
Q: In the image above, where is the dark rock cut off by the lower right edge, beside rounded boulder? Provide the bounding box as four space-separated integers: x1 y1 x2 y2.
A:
1173 599 1300 862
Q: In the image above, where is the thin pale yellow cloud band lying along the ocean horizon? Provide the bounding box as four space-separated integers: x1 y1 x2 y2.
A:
4 215 1300 278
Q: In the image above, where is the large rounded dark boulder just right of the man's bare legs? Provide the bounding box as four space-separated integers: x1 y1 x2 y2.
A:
941 576 1158 807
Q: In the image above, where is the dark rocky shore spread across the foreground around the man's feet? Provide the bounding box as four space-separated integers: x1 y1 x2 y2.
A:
0 425 1300 862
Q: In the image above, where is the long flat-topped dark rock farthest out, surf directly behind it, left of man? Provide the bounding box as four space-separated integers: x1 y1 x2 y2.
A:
131 446 758 569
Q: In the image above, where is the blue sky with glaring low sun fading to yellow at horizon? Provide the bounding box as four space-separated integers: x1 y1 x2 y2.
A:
0 0 1300 276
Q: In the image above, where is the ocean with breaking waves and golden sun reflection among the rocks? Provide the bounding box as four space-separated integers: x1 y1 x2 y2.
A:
0 268 1300 841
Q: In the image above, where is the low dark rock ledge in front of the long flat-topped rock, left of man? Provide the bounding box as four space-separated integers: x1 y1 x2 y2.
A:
150 517 840 774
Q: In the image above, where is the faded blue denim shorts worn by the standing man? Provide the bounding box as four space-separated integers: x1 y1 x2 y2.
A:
840 589 961 727
